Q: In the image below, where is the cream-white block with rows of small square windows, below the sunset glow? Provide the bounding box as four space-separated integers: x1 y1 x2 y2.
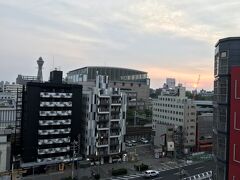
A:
152 85 196 148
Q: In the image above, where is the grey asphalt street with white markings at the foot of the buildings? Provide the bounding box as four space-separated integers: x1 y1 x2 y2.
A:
23 144 214 180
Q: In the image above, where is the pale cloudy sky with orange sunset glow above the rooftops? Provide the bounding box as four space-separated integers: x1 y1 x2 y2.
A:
0 0 240 90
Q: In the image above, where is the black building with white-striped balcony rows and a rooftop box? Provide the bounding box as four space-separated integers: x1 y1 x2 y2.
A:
21 70 82 167
